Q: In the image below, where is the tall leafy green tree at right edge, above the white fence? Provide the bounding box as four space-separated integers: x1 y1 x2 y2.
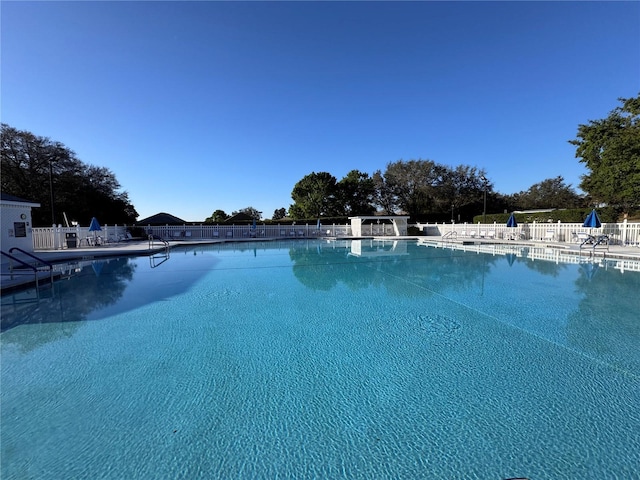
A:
569 95 640 212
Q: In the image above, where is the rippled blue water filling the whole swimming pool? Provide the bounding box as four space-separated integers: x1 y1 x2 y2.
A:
0 240 640 480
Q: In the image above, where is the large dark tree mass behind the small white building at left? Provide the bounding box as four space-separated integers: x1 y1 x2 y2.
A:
1 124 138 226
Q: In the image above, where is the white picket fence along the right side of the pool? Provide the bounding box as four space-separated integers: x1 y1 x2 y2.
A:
416 220 640 247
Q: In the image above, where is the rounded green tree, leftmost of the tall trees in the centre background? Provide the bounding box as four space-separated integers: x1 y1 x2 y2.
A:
289 172 336 219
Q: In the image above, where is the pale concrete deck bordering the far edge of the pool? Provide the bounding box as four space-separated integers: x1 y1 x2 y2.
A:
0 236 640 294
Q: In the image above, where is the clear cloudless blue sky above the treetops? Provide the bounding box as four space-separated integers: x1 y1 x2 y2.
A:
1 1 640 221
